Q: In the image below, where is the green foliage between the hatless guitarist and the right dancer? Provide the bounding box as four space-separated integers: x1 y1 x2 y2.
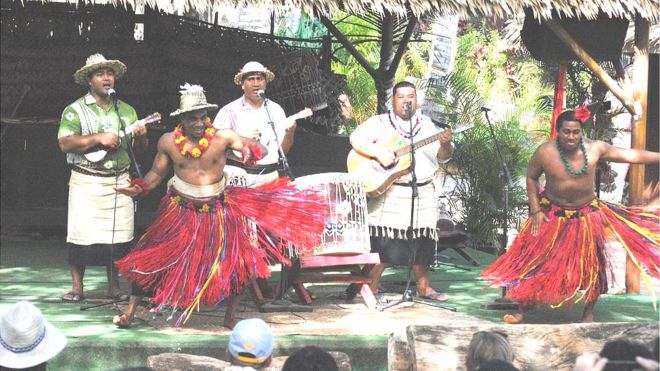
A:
430 25 552 250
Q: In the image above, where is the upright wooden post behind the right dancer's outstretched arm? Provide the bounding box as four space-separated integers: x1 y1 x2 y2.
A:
626 14 649 293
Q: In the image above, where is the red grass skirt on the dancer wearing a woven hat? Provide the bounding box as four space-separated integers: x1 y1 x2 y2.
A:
115 178 328 324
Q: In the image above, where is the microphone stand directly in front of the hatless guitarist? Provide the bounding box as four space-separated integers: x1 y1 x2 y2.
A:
378 107 456 312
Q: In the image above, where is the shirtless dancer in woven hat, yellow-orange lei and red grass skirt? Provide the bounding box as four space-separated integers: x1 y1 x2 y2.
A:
113 84 327 328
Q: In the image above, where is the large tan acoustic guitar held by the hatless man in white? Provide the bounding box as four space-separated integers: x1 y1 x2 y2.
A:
346 124 474 197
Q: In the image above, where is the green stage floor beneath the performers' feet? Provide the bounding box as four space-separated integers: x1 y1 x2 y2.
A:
0 229 658 371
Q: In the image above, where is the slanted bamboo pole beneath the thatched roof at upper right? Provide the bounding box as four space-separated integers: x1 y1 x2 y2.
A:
545 20 638 115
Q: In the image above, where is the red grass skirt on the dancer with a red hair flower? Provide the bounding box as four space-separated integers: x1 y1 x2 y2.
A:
482 197 660 307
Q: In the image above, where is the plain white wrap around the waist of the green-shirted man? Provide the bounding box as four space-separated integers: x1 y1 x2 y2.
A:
66 171 135 246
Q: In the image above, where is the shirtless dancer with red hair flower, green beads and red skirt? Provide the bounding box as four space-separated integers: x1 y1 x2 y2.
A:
483 108 660 323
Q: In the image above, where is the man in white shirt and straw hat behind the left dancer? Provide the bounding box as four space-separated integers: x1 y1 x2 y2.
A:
213 62 296 185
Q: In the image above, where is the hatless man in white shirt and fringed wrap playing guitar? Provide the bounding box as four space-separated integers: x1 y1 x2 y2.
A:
350 81 454 301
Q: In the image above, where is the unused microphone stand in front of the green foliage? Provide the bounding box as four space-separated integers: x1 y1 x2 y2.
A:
481 108 519 310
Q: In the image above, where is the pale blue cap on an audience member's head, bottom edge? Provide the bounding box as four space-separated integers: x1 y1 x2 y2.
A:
227 318 274 365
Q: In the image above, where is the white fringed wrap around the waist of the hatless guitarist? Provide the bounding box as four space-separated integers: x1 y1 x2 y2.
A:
367 182 438 240
